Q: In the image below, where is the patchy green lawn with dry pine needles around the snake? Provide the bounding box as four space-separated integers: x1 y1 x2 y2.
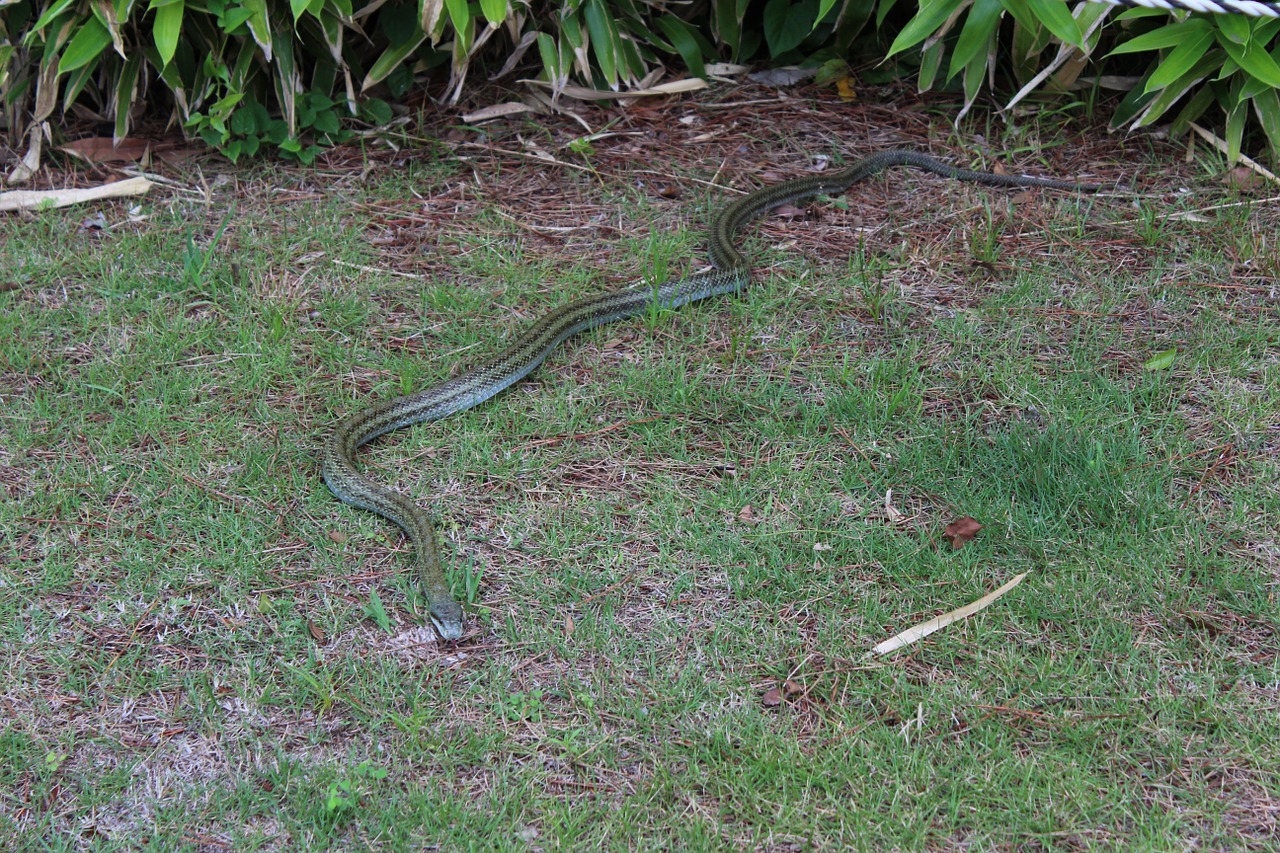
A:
0 136 1280 850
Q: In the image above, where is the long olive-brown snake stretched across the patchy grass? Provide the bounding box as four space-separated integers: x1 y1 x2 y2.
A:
320 149 1102 640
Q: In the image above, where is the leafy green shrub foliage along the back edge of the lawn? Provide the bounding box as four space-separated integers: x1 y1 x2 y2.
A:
0 0 1280 161
